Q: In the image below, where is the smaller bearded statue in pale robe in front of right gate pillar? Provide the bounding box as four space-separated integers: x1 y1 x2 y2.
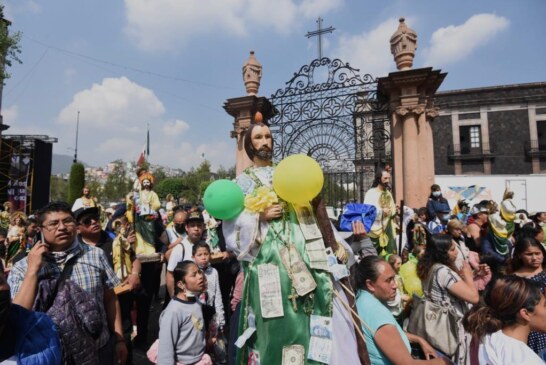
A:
364 170 397 257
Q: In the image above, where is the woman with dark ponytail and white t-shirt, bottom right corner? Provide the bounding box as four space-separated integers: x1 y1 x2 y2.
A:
463 276 546 365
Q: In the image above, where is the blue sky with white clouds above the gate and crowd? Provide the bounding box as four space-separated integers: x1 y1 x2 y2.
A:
0 0 546 170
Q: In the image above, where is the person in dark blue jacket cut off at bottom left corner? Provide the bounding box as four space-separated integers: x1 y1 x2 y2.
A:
0 255 61 365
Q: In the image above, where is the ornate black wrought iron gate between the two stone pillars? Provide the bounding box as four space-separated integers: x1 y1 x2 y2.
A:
269 58 391 206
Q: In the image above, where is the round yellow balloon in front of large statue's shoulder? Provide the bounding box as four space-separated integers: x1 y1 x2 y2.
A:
273 154 324 205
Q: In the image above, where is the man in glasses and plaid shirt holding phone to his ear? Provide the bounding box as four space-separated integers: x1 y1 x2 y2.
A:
8 202 127 364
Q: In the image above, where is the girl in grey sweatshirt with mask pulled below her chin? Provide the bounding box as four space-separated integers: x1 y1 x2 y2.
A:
157 261 212 365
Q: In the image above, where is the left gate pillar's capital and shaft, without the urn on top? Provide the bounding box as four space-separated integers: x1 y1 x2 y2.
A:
224 95 274 175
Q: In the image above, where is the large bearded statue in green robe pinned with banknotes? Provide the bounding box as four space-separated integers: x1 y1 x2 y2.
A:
223 124 361 365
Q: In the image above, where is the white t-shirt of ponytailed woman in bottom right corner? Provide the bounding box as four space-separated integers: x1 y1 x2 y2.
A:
478 330 544 365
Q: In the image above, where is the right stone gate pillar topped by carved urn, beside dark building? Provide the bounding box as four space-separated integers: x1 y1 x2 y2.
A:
378 18 447 208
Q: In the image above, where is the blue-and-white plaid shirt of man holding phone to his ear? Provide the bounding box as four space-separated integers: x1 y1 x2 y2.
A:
8 241 121 348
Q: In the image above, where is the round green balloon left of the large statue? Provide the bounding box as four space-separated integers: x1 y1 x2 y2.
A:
203 179 244 220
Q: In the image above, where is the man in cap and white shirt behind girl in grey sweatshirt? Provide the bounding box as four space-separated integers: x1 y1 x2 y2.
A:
165 212 205 298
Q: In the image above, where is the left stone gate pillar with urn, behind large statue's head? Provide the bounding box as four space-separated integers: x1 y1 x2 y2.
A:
224 51 273 175
